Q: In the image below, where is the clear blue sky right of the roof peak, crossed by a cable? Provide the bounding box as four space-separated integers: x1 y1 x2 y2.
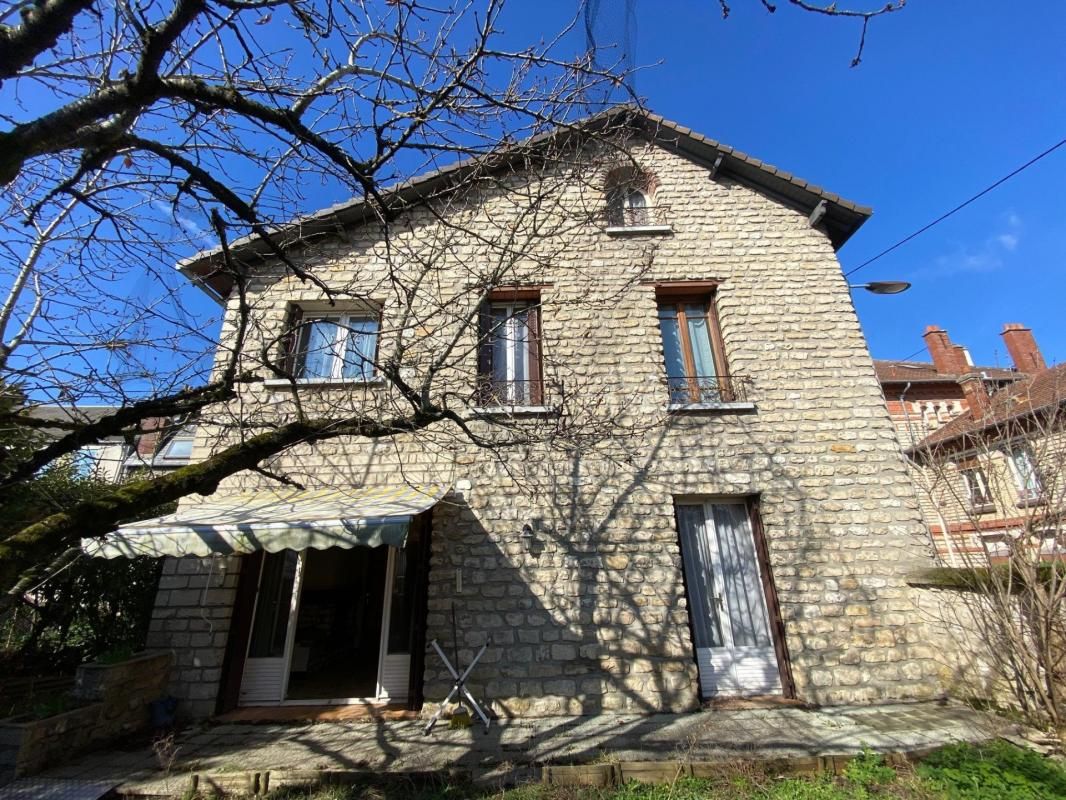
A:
508 0 1066 364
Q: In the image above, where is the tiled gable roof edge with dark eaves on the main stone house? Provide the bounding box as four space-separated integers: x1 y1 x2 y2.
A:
178 105 873 300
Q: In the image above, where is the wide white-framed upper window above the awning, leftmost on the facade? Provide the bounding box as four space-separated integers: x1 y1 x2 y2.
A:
292 313 381 381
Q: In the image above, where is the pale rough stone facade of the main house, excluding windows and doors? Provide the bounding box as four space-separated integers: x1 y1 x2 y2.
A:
146 123 937 715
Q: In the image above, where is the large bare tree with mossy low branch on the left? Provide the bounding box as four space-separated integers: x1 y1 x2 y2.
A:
0 0 648 597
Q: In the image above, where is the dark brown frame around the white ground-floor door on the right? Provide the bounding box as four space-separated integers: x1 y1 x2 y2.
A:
673 495 795 701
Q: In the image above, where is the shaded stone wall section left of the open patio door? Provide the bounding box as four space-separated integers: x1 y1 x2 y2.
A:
146 556 241 718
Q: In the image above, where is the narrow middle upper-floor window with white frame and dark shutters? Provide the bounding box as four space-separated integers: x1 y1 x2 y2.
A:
477 290 544 406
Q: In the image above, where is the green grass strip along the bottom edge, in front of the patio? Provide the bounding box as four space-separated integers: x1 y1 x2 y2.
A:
191 741 1066 800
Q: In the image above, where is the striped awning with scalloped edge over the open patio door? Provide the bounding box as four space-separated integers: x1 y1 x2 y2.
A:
81 484 449 558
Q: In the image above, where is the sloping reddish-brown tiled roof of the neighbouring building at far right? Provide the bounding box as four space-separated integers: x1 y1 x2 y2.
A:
911 364 1066 451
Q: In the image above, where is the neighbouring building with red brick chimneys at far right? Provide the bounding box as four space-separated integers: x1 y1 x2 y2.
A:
875 323 1066 565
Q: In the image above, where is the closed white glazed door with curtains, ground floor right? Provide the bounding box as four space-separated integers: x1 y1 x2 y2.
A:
677 500 781 698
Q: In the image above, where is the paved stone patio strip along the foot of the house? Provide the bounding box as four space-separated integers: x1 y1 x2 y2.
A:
27 703 1013 796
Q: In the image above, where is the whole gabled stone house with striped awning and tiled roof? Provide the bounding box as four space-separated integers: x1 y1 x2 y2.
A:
86 108 937 716
